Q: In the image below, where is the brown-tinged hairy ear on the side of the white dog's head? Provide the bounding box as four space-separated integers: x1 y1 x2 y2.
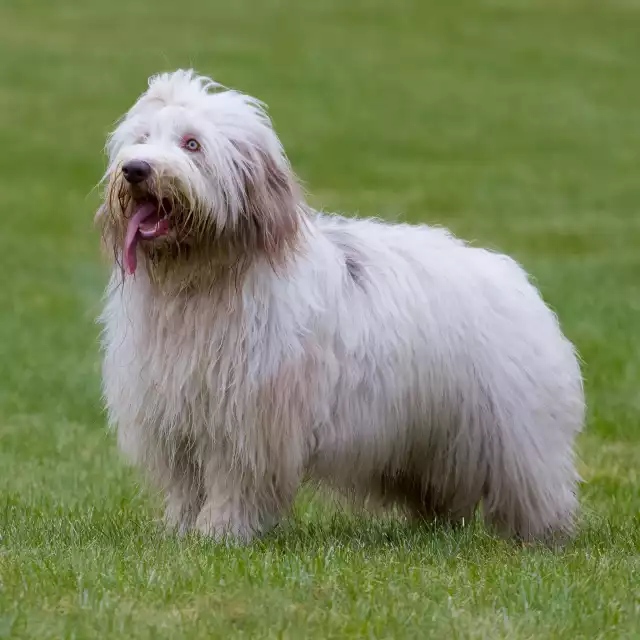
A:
236 145 301 265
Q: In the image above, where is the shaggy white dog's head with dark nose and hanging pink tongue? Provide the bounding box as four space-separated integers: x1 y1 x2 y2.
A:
97 71 299 273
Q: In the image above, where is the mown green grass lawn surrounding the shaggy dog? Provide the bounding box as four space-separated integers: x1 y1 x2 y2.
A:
0 0 640 639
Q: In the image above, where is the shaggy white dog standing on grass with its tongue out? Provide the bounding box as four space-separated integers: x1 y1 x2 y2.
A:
97 71 584 541
